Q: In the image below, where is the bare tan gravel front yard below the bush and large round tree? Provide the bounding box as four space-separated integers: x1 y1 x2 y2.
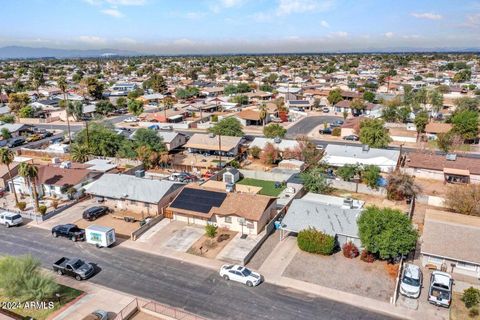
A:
283 252 395 302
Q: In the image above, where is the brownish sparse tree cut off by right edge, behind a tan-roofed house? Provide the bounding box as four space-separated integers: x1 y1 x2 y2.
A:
445 184 480 216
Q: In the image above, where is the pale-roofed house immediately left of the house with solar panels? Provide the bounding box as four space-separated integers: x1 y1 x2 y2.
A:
86 173 184 216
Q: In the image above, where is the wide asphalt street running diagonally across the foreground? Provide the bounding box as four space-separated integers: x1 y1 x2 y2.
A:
0 226 393 320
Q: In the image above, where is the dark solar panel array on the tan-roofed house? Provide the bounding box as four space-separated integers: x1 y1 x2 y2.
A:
170 188 227 213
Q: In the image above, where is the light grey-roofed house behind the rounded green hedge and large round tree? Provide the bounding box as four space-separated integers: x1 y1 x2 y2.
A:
281 193 364 247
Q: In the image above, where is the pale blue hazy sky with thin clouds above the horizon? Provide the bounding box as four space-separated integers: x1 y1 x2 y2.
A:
0 0 480 54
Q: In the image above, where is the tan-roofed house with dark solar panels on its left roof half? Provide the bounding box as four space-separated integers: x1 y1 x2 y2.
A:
165 185 277 235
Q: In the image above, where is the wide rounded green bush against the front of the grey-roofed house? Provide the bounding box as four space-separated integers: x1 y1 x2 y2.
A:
297 228 336 255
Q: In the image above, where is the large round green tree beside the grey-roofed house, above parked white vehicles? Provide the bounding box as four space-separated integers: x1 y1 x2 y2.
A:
357 206 418 259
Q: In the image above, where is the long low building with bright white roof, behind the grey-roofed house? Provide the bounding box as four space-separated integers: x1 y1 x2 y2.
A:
322 144 400 172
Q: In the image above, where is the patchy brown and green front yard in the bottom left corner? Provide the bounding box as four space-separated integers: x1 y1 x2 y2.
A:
0 285 83 320
